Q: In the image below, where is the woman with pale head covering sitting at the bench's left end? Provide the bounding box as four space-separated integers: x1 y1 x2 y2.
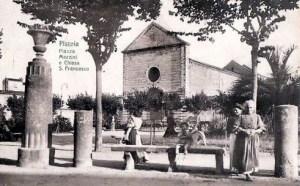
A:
123 111 148 163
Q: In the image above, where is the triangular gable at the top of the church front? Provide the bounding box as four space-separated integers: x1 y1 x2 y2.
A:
122 22 189 53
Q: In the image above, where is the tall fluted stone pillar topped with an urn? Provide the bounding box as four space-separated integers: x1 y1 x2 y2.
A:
18 25 53 168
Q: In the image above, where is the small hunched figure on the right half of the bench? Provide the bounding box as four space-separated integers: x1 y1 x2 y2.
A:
176 122 206 154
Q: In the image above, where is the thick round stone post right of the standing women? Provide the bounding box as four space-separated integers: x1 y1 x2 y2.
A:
274 105 298 179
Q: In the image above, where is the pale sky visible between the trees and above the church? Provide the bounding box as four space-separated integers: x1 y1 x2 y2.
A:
0 0 300 99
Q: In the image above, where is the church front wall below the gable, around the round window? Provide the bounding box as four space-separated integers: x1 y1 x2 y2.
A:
123 45 186 96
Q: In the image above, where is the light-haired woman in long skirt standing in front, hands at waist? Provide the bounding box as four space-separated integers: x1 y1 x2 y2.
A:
232 100 265 181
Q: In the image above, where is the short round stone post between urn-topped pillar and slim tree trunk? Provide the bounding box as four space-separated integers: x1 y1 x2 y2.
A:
73 111 93 167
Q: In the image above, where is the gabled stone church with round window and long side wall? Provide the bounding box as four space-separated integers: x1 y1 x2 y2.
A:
123 23 240 97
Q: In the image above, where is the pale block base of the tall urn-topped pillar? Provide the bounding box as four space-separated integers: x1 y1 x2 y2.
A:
18 148 49 168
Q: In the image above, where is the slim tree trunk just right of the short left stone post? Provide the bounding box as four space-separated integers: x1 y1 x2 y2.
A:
95 63 102 151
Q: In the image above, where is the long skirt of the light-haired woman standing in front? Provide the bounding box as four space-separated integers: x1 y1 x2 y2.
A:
232 133 259 173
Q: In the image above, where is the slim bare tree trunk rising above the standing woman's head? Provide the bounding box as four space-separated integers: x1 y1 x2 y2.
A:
251 42 259 109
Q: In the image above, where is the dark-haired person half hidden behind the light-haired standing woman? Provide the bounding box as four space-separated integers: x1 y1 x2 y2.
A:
226 103 244 173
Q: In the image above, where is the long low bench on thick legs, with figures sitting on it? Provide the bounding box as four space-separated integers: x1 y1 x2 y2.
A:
111 145 225 174
